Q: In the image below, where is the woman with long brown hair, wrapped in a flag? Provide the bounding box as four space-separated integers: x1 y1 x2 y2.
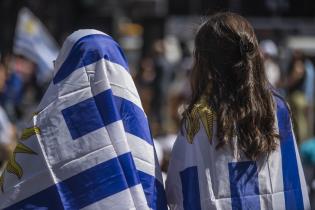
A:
166 13 310 210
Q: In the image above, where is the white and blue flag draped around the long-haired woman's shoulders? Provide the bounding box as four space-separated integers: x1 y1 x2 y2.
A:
166 96 310 210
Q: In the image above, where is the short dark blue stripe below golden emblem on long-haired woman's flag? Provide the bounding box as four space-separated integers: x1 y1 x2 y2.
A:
180 166 201 210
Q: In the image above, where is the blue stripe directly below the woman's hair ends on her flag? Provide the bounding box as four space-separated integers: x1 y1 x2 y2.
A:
229 161 260 210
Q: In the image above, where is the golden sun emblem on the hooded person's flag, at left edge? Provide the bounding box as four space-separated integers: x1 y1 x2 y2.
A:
0 127 40 192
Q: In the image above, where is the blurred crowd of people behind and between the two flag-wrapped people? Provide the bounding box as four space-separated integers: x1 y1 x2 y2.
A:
0 28 315 208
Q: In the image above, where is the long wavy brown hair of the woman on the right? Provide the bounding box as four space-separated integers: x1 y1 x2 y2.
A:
183 12 279 160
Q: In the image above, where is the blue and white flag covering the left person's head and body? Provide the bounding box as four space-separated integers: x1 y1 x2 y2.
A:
0 30 167 210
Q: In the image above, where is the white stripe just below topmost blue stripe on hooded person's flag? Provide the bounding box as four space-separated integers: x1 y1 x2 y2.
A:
51 59 143 113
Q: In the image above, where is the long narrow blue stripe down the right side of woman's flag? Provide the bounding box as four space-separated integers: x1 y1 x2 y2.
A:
276 97 304 210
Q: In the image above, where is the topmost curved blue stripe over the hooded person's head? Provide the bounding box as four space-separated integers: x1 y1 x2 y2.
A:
53 34 128 84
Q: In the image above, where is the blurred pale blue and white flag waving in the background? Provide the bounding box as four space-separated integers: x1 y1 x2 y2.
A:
13 8 59 82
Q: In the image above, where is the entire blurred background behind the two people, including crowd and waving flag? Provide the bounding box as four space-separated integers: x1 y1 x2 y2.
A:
0 0 315 209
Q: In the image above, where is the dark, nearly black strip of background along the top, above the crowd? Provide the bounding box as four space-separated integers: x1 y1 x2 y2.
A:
0 0 315 54
